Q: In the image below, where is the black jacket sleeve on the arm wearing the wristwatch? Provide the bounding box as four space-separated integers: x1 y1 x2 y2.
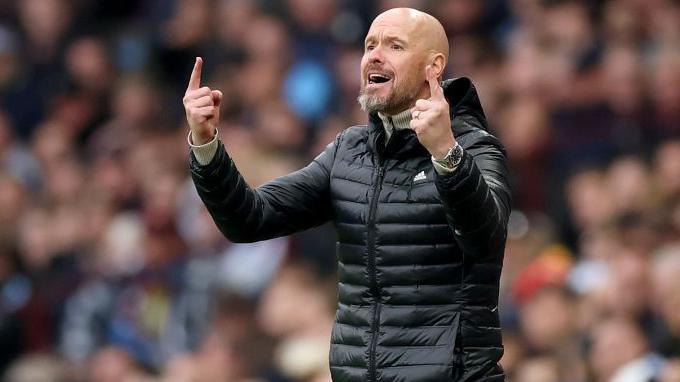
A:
436 121 510 256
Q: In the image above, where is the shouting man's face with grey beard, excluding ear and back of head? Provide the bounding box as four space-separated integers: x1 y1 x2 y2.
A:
357 15 427 114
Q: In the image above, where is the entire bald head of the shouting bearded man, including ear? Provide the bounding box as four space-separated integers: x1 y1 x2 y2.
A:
358 8 448 115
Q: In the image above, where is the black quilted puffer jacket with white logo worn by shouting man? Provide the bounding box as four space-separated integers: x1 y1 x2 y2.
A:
191 78 510 382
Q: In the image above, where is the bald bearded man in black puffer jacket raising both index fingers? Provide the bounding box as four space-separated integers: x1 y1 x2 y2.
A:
184 8 510 382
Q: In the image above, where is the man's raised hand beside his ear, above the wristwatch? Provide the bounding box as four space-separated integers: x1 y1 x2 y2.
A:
411 65 456 159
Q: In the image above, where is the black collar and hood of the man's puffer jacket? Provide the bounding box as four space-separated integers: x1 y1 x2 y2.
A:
367 77 488 158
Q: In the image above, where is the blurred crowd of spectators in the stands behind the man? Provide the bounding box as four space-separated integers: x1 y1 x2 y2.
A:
0 0 680 382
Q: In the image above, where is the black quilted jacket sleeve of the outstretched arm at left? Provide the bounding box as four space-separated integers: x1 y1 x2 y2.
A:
189 135 340 243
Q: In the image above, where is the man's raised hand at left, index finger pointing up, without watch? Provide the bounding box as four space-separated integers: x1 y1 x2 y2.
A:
182 57 222 145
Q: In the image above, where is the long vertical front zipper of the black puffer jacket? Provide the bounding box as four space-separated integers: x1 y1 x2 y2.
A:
367 164 385 382
